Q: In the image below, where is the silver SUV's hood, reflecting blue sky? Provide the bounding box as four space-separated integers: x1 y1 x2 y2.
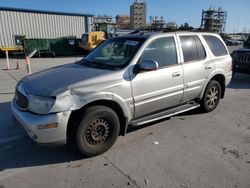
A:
19 64 119 96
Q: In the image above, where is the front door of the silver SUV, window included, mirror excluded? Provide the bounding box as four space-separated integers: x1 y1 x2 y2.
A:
132 35 183 118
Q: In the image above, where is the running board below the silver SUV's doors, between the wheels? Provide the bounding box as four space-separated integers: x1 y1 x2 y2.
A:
130 102 200 126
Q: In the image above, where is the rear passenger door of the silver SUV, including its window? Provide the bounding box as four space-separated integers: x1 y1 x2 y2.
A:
178 34 215 103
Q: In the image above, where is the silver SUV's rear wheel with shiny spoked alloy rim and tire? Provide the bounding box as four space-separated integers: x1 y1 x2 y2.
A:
201 80 221 112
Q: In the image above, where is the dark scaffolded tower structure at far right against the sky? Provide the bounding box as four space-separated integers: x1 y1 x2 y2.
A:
201 7 227 33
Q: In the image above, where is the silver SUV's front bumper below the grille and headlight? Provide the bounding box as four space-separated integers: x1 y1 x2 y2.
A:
11 100 71 144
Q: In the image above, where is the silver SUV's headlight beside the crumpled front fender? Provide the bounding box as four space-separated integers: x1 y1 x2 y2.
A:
28 95 56 114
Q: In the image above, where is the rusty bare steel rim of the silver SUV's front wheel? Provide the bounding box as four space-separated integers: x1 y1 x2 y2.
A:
85 118 111 145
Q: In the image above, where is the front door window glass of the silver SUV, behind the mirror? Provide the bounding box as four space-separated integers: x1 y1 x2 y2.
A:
141 37 178 68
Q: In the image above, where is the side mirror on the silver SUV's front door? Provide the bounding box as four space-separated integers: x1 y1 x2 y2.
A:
133 60 159 74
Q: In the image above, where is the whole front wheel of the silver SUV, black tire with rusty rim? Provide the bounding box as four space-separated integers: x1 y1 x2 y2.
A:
75 106 120 157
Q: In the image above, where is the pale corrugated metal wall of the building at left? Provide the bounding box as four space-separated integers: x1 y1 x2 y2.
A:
0 10 88 47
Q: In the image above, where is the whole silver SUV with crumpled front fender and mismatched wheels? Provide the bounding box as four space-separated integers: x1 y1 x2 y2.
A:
12 32 232 156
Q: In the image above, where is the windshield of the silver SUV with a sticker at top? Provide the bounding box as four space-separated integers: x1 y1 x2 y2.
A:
84 37 145 69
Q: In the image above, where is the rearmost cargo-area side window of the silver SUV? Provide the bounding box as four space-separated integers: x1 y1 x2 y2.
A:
203 35 227 56
